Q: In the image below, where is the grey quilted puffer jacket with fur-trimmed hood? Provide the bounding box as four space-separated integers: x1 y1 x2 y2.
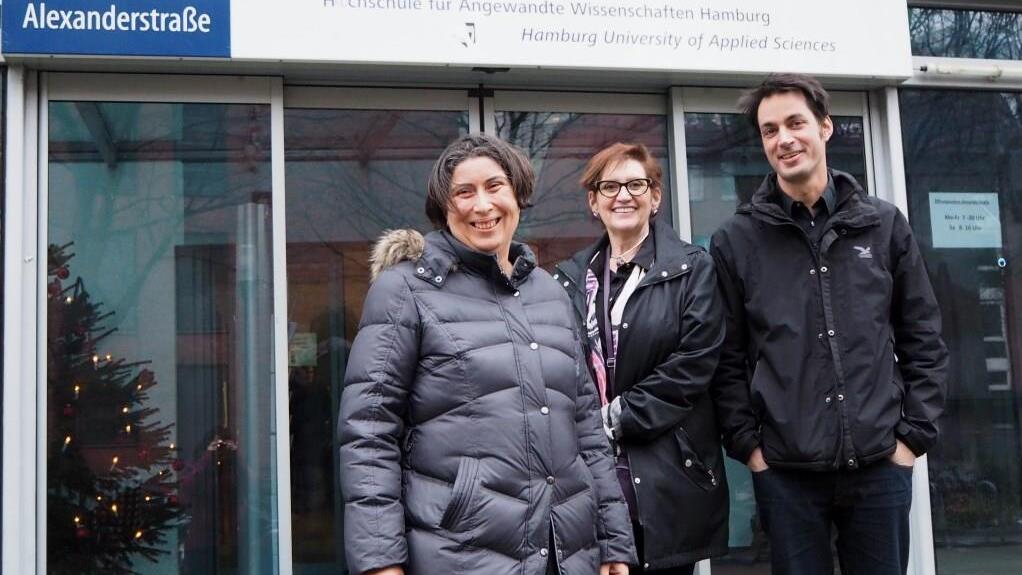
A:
338 231 635 575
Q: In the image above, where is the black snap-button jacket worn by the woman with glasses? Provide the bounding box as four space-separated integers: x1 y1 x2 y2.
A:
555 221 729 570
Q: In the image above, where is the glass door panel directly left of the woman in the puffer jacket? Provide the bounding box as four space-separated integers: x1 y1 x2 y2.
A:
284 108 468 575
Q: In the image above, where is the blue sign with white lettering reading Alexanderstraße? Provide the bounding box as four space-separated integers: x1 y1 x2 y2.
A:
2 0 231 57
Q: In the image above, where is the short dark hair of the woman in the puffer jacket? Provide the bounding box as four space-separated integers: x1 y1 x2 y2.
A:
426 134 536 230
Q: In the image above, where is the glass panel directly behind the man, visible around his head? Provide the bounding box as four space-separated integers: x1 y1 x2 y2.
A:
685 113 867 575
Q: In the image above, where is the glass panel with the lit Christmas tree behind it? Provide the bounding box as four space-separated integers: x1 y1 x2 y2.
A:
46 102 277 575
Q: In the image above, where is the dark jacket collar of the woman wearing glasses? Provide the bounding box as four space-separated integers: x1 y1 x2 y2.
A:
556 220 700 293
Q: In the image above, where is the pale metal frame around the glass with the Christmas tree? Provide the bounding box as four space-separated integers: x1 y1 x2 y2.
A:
12 72 292 575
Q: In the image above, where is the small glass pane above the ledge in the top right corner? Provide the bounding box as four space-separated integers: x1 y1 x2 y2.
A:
909 8 1022 60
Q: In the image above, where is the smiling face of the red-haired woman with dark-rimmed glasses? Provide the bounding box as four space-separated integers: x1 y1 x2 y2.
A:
589 158 660 238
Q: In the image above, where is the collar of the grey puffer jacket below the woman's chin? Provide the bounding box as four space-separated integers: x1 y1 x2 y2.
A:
415 230 536 288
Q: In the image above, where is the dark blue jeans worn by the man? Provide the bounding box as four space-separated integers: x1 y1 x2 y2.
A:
752 460 912 575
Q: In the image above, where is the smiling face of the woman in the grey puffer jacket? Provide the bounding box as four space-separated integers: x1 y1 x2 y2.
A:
447 156 521 259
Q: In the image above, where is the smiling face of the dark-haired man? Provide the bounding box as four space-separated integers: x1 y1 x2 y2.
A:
758 92 834 186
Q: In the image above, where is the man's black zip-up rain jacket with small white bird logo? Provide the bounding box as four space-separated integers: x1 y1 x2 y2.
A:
710 171 947 470
